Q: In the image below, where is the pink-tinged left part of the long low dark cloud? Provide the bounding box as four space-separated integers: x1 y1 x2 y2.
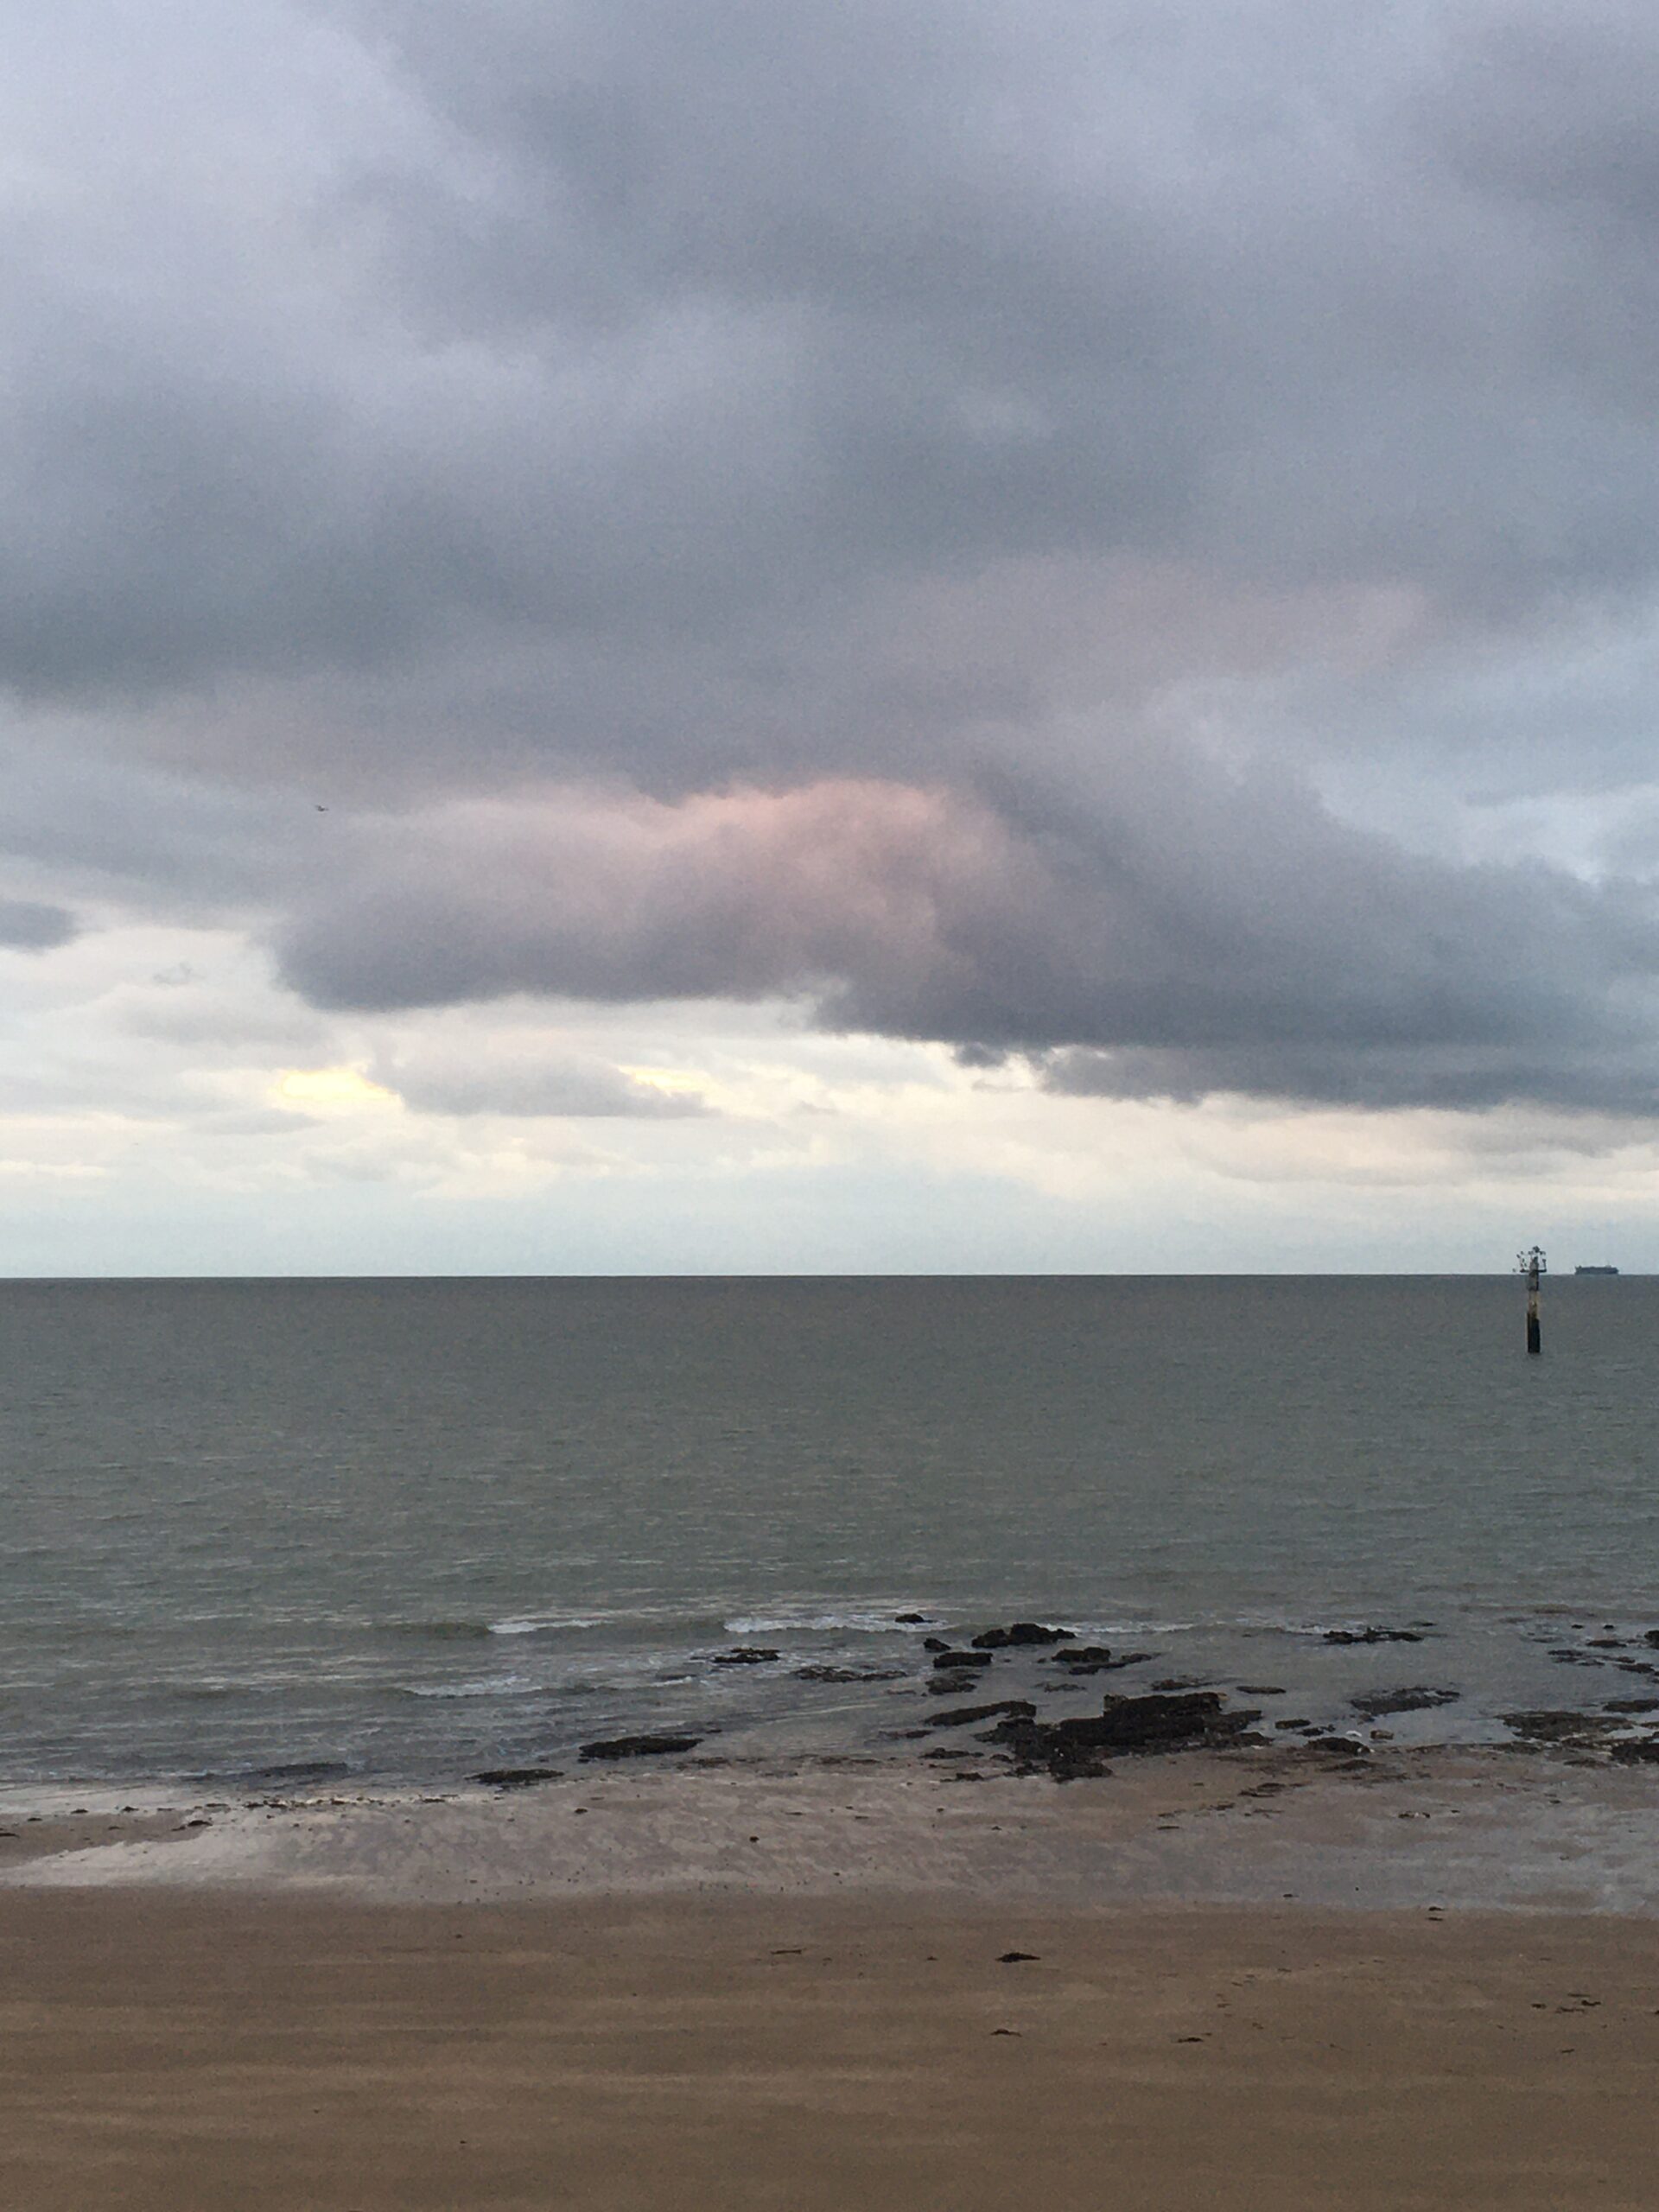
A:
283 781 1020 1007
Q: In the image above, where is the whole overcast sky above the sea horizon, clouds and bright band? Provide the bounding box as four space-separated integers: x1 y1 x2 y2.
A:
0 0 1659 1274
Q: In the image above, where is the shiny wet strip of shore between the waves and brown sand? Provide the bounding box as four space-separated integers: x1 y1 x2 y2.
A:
0 1745 1659 1918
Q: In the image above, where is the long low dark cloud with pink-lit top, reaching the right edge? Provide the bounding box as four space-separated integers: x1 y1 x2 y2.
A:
279 752 1659 1110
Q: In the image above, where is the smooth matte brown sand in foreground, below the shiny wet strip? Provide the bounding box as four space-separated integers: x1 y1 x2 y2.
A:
0 1889 1659 2212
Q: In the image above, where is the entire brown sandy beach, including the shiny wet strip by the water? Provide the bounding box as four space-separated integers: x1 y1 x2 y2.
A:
0 1752 1659 2212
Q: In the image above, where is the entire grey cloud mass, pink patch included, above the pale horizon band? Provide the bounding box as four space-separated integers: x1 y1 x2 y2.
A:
0 0 1659 1113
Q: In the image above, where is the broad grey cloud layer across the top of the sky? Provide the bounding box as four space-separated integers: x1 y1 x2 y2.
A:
0 0 1659 698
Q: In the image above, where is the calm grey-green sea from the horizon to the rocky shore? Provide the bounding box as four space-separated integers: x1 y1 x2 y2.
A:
0 1276 1659 1781
